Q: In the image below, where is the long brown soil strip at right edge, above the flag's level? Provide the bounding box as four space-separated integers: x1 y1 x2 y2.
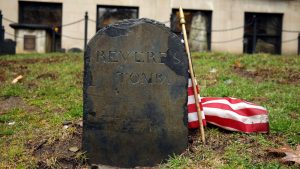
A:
233 67 300 84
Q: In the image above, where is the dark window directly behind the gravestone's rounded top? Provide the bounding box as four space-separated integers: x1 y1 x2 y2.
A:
96 6 139 31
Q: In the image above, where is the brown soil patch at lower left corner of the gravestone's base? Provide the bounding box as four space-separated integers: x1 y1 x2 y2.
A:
31 124 85 169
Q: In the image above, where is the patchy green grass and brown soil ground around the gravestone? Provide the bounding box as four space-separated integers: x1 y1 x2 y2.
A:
0 53 300 168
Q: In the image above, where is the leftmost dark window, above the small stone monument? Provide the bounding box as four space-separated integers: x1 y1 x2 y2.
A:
19 1 62 49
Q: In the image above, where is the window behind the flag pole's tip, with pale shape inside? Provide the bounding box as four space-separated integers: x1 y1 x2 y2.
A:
171 9 212 51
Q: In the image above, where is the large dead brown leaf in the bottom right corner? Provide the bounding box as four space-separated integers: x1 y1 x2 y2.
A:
268 145 300 164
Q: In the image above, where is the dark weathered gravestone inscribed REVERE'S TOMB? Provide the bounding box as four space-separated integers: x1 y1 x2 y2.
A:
83 19 188 167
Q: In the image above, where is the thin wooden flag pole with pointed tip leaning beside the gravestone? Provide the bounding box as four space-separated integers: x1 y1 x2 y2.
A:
179 6 205 144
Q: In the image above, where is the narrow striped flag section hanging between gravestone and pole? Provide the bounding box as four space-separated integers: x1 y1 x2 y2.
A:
187 79 206 128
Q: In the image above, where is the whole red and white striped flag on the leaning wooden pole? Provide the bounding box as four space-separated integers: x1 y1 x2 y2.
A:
181 34 269 133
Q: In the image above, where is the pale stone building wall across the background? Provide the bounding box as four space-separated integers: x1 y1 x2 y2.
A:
0 0 300 54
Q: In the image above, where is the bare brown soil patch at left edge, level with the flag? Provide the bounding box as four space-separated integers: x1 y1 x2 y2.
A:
0 97 38 115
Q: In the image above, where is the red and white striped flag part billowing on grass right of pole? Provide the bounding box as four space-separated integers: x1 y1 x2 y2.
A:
201 97 269 133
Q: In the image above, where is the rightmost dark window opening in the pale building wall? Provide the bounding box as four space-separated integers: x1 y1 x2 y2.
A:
244 12 283 54
